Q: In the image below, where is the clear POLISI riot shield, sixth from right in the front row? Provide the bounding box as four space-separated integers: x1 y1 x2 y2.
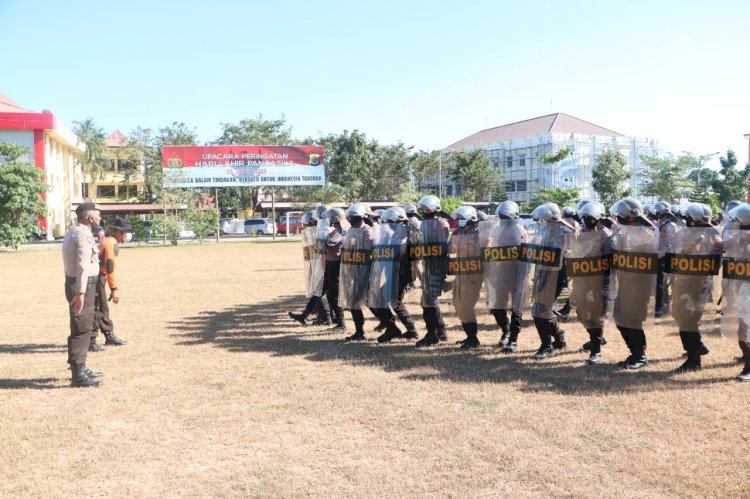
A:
479 219 529 311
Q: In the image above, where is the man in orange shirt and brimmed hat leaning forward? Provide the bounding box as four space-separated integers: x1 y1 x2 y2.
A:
89 218 133 352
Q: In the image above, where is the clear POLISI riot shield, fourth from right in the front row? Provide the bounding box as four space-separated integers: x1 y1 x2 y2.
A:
565 228 612 329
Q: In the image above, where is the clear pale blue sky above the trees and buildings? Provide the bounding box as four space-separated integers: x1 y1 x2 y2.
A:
0 0 750 168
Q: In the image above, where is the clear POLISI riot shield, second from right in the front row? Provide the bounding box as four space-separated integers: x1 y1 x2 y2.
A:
664 226 722 333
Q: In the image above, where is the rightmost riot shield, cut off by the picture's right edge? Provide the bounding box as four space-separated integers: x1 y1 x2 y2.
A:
721 230 750 342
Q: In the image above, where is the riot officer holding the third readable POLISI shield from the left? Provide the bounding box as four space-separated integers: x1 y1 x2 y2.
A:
409 195 450 347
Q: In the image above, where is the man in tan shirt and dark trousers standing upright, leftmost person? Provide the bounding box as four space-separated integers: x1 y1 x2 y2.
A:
62 202 102 387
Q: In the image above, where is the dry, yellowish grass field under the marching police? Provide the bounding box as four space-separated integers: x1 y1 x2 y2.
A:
0 242 750 497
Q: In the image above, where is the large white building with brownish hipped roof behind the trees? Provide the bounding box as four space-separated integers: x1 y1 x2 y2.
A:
443 113 659 202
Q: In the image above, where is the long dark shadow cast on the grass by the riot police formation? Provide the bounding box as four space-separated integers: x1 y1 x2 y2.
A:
170 295 730 395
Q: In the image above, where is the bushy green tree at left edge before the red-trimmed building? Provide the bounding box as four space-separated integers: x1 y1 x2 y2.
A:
0 143 47 249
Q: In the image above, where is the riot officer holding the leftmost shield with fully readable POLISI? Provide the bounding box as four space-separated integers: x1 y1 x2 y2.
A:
339 203 373 341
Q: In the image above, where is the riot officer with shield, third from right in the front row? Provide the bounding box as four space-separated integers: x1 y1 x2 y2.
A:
610 198 659 369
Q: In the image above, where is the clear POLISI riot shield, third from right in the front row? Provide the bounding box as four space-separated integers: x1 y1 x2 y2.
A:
609 225 659 329
